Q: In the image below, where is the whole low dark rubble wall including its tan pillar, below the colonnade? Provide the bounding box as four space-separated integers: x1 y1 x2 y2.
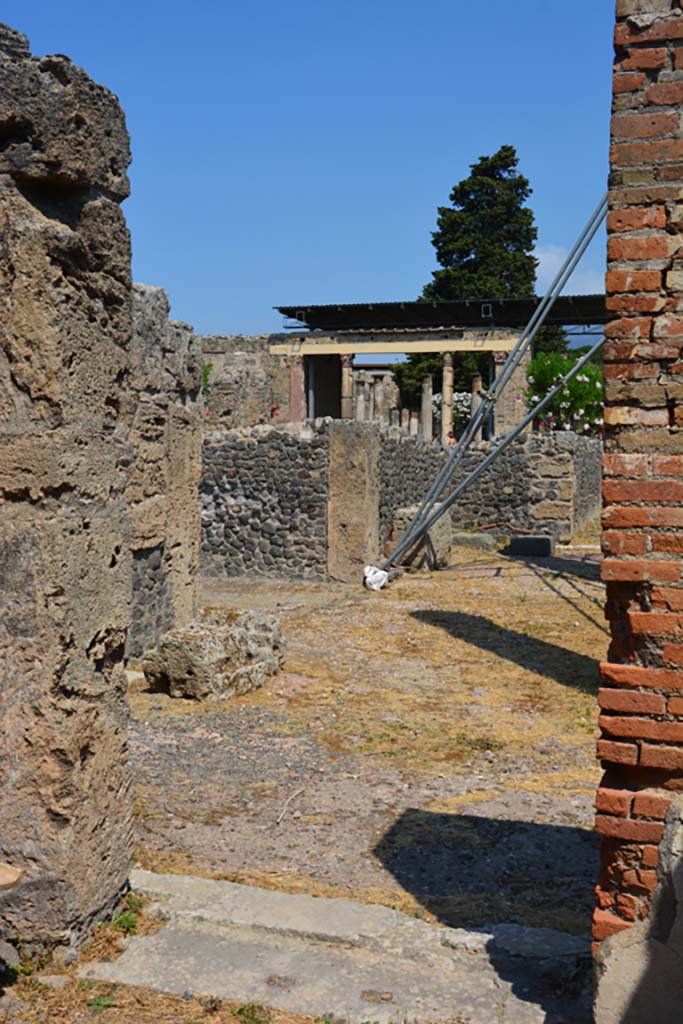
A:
201 420 601 581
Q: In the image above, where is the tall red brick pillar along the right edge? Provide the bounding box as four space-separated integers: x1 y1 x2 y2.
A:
594 0 683 940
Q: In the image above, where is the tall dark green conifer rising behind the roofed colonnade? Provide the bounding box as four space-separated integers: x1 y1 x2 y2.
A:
395 145 566 407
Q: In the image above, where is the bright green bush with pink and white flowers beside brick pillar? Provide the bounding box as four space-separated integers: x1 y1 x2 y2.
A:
520 352 602 436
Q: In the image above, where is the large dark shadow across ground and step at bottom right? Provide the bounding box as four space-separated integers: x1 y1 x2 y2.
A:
374 808 599 1024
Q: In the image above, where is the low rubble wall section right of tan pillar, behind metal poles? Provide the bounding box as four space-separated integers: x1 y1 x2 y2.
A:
380 431 601 544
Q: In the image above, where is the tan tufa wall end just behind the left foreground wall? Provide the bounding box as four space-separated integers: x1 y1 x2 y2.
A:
126 285 203 657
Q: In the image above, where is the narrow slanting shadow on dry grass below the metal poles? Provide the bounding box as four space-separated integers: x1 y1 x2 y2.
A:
411 610 598 693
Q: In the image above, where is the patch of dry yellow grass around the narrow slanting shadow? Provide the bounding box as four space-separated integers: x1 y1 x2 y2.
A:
248 553 607 773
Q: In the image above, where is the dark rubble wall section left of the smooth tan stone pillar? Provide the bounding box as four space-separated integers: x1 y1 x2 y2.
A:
200 423 329 580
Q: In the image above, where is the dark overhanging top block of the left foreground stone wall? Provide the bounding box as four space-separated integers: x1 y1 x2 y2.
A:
0 25 130 200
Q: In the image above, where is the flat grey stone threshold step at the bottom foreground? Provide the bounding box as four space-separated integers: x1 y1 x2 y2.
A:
81 871 590 1024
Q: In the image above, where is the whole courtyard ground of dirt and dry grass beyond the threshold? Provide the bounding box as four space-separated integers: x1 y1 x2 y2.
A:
131 551 607 933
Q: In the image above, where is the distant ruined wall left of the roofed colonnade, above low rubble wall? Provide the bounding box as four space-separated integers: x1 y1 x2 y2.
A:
199 334 290 430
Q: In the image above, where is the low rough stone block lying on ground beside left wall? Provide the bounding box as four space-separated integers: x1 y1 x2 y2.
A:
142 611 284 700
